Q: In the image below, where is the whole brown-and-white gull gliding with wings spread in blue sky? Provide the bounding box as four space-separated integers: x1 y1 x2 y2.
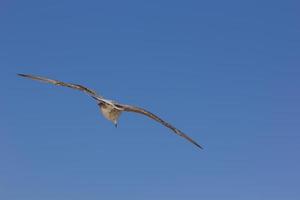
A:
17 74 203 149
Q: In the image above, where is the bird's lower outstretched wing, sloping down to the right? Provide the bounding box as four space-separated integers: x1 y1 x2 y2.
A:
115 103 203 149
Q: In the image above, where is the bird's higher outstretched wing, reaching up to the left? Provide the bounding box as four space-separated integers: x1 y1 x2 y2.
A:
18 74 103 100
